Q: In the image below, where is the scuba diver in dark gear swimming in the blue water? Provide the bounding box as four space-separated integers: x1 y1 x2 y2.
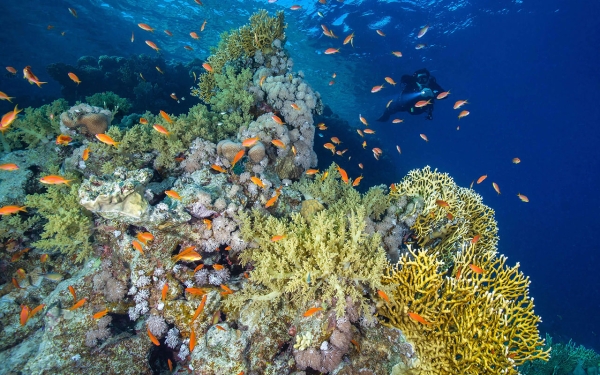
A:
377 68 445 122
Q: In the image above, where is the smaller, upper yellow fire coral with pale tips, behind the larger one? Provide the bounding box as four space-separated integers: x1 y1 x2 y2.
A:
390 166 498 269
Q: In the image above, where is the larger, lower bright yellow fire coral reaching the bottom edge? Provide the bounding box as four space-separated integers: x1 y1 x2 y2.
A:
378 244 549 375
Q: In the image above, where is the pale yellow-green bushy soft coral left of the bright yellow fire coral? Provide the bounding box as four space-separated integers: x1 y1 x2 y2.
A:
227 207 385 316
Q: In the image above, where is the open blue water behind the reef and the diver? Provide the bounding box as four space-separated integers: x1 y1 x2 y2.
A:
0 0 600 350
